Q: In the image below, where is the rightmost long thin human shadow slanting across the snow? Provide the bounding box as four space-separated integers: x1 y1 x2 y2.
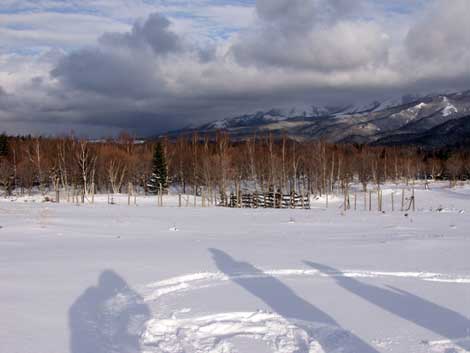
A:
304 261 470 350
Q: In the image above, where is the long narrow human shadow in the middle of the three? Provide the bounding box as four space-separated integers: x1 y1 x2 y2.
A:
209 249 378 353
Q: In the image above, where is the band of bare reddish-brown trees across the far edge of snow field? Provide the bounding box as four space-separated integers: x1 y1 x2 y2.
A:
0 131 470 195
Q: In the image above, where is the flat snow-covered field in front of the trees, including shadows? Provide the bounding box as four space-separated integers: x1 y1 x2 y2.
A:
0 185 470 353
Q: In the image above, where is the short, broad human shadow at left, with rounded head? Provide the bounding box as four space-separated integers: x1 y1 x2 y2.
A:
69 270 150 353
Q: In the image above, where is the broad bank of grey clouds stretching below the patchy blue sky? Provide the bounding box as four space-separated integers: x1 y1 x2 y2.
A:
0 0 470 136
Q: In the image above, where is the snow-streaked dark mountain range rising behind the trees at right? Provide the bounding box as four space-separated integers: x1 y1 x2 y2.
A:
168 91 470 144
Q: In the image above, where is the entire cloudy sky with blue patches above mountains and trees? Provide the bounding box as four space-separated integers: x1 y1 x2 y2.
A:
0 0 470 137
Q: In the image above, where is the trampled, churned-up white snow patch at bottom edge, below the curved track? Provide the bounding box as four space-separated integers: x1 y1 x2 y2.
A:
142 311 364 353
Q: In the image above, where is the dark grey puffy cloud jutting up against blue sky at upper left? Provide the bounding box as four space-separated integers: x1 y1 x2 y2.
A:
51 14 182 99
